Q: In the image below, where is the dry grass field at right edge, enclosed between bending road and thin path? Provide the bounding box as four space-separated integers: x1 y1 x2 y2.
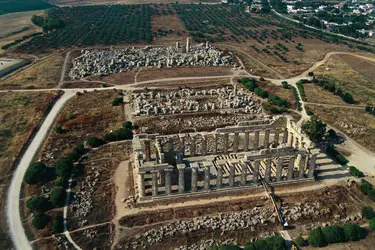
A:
314 55 375 104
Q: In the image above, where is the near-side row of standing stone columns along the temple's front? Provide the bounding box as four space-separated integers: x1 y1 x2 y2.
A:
138 154 317 197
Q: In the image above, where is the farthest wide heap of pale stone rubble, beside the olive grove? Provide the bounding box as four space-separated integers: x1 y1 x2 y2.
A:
69 44 235 79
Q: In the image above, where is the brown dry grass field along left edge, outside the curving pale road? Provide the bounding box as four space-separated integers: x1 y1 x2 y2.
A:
0 92 58 249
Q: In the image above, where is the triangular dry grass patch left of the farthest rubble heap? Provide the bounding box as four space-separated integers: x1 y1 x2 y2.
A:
0 55 64 89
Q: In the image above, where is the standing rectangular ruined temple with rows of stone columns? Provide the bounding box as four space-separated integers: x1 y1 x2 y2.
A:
133 117 317 200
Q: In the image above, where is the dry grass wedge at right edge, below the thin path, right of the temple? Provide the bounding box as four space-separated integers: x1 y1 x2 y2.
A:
308 105 375 151
